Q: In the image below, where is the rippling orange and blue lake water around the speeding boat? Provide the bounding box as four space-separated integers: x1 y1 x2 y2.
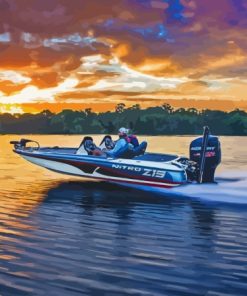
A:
0 136 247 296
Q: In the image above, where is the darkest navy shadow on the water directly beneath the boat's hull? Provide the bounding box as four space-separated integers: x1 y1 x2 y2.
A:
44 181 184 219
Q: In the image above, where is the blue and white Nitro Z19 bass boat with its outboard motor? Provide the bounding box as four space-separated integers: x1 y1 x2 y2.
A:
10 127 221 188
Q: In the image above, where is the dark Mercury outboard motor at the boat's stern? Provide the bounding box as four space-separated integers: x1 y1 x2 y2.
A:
190 126 221 183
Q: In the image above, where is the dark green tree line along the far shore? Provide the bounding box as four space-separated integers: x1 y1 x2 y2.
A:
0 103 247 136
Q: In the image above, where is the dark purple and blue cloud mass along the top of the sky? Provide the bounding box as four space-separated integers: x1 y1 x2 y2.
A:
0 0 247 67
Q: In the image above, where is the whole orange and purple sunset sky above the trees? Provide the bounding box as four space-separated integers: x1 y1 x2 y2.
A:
0 0 247 113
